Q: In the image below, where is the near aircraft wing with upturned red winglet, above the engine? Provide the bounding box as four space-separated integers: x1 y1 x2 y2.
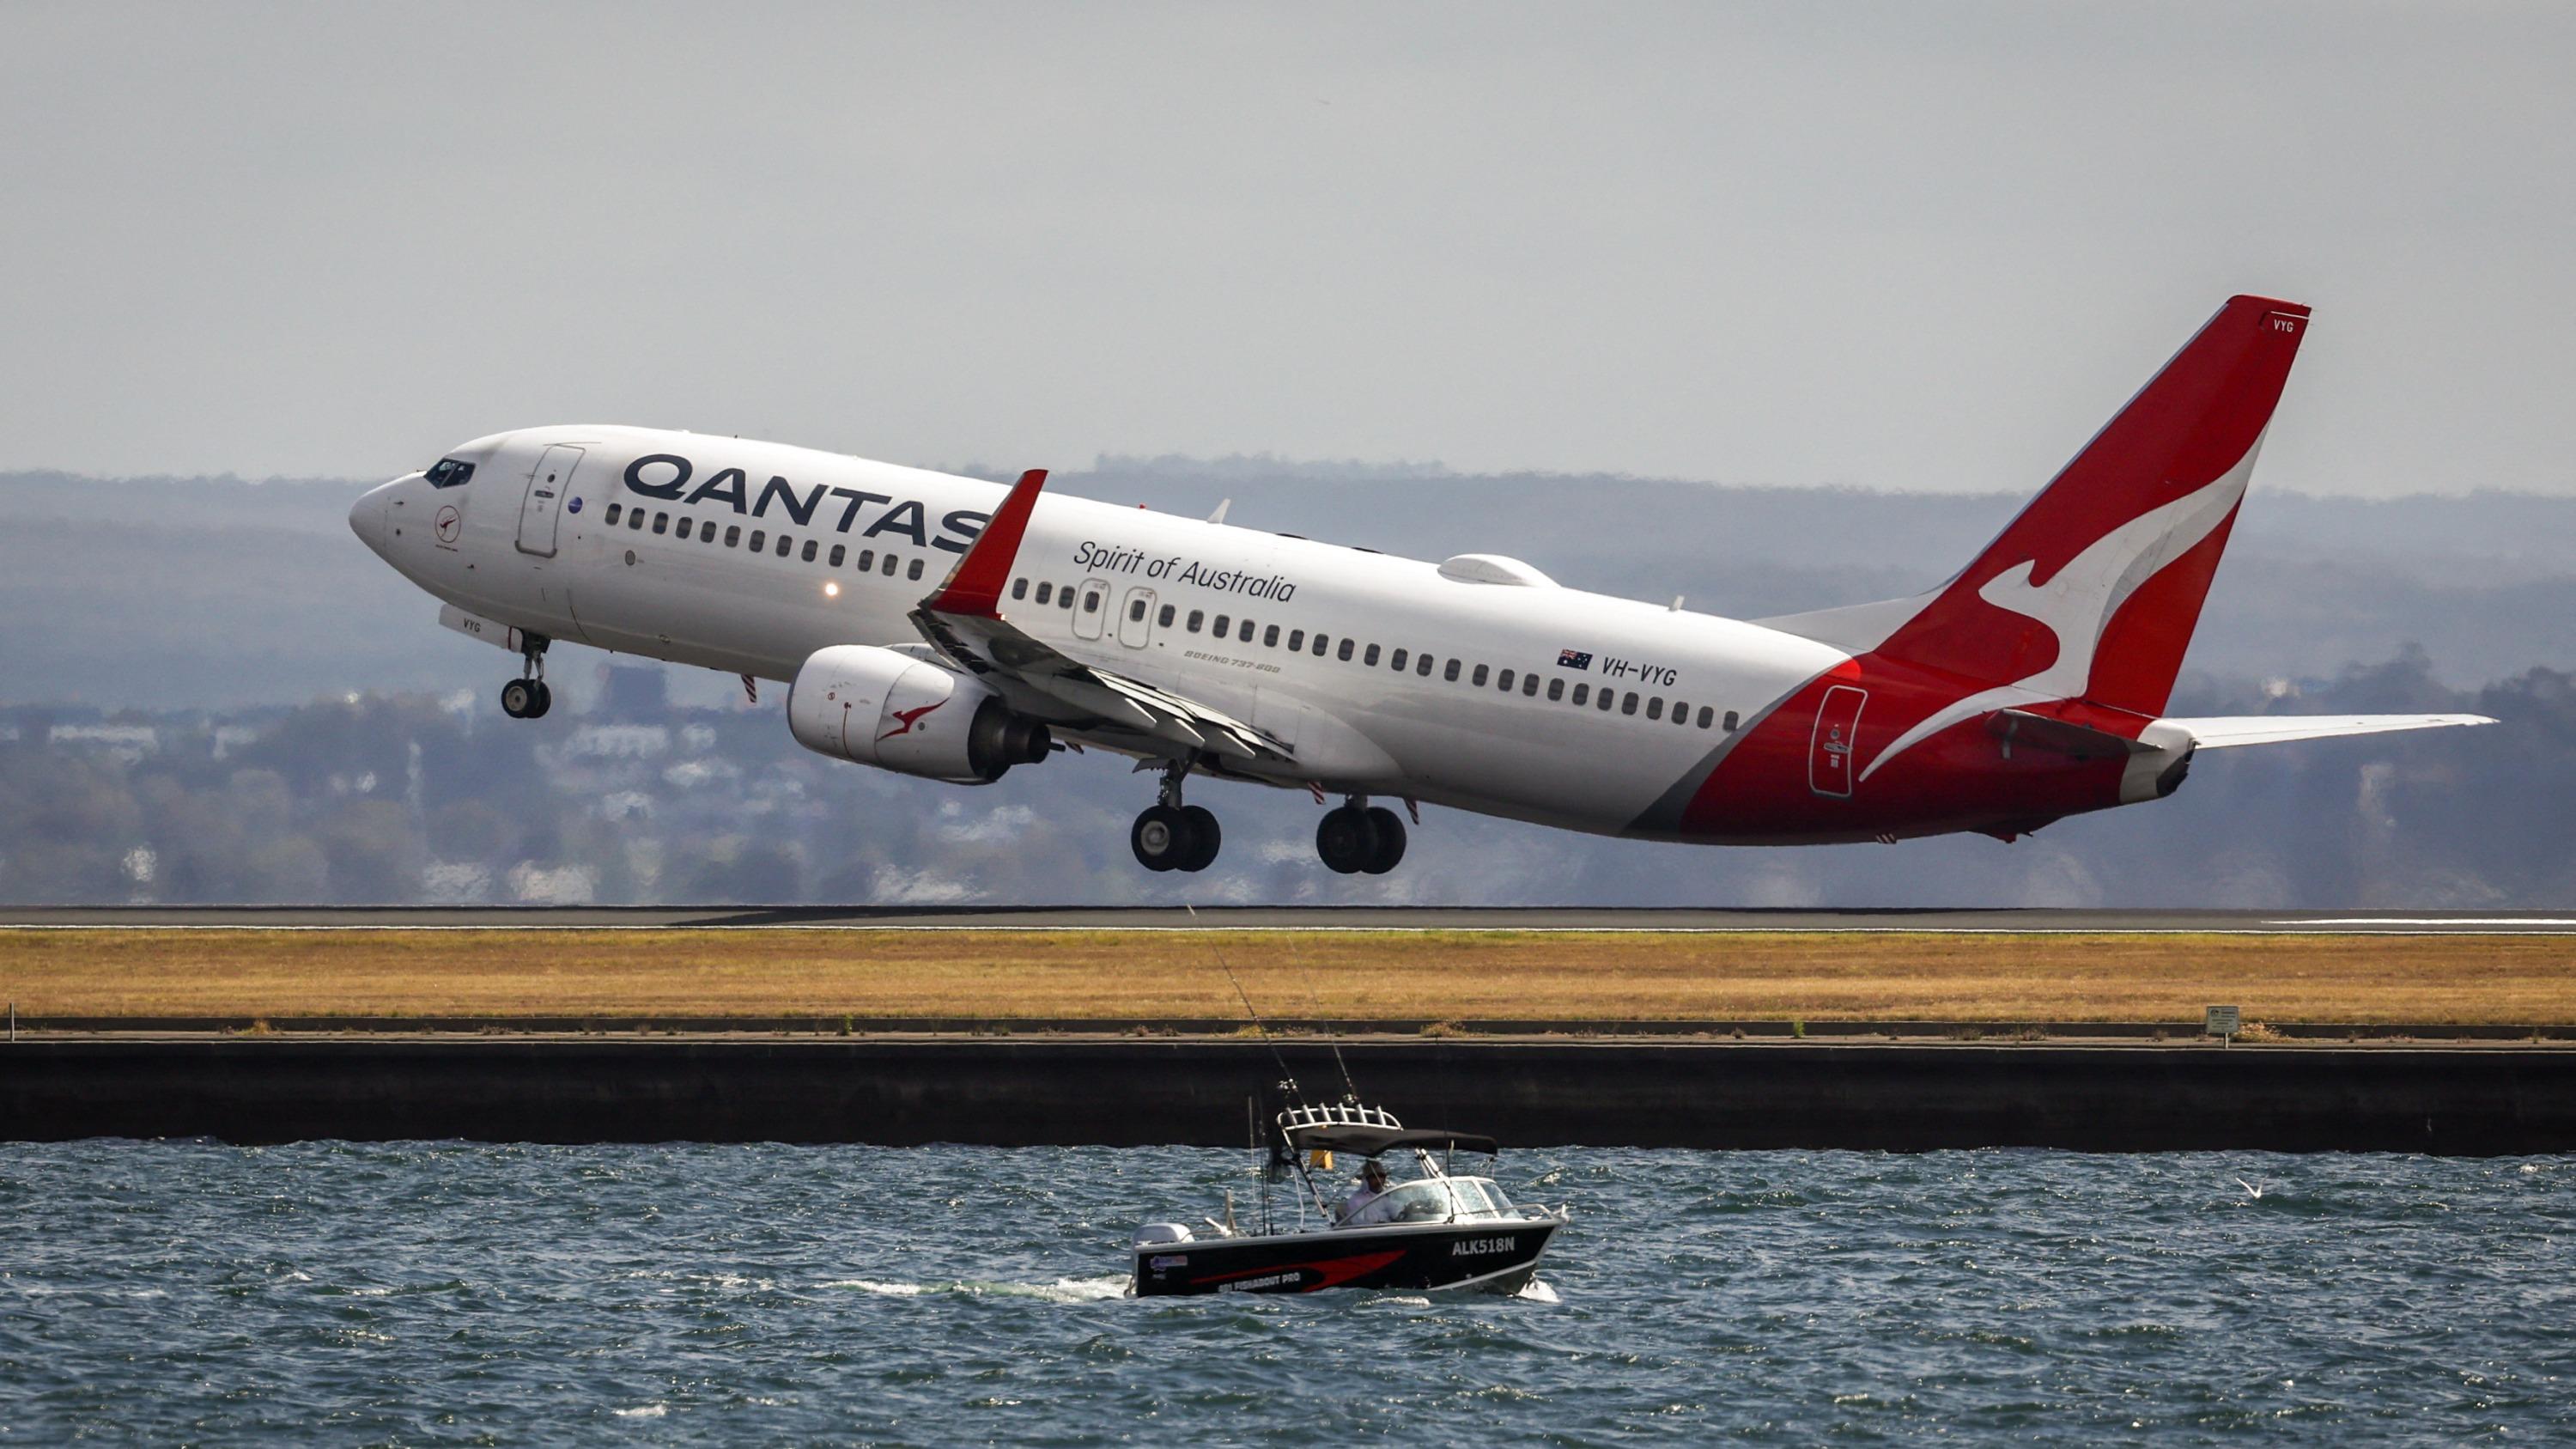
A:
912 469 1293 764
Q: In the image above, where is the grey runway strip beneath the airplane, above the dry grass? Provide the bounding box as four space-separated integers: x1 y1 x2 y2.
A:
0 905 2576 936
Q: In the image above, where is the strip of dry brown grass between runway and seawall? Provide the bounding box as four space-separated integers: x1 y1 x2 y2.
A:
0 931 2576 1024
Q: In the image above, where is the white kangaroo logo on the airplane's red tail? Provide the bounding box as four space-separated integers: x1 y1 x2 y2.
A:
1860 435 2262 779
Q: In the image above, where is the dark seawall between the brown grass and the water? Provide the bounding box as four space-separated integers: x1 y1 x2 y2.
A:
0 1037 2576 1155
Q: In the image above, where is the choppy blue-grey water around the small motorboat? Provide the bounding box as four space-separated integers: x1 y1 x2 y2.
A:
0 1142 2576 1444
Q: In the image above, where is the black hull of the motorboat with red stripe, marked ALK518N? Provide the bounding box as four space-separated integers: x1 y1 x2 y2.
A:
1136 1217 1564 1297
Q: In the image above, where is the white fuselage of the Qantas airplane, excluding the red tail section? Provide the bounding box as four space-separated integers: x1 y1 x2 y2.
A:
353 425 1850 833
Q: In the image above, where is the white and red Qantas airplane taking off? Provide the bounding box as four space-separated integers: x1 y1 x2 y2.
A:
350 296 2494 874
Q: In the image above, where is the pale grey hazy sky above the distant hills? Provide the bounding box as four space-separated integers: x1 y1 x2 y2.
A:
0 0 2576 492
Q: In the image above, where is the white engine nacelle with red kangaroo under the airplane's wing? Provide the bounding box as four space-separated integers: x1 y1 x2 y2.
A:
788 644 1054 784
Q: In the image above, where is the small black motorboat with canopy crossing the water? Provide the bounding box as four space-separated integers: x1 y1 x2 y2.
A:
1131 1104 1566 1297
